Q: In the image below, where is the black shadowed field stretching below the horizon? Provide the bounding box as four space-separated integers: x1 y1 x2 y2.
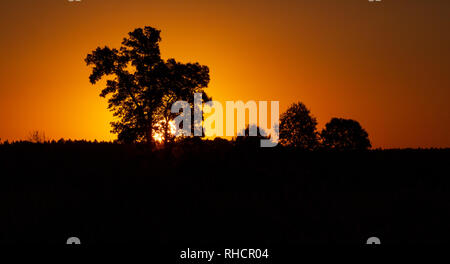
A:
0 142 450 244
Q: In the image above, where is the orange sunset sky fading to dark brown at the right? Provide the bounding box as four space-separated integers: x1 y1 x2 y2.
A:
0 0 450 148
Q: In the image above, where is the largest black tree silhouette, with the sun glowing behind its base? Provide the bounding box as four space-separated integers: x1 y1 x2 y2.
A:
85 27 209 143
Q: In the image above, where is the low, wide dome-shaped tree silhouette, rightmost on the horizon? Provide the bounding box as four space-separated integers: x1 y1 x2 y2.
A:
321 118 372 150
